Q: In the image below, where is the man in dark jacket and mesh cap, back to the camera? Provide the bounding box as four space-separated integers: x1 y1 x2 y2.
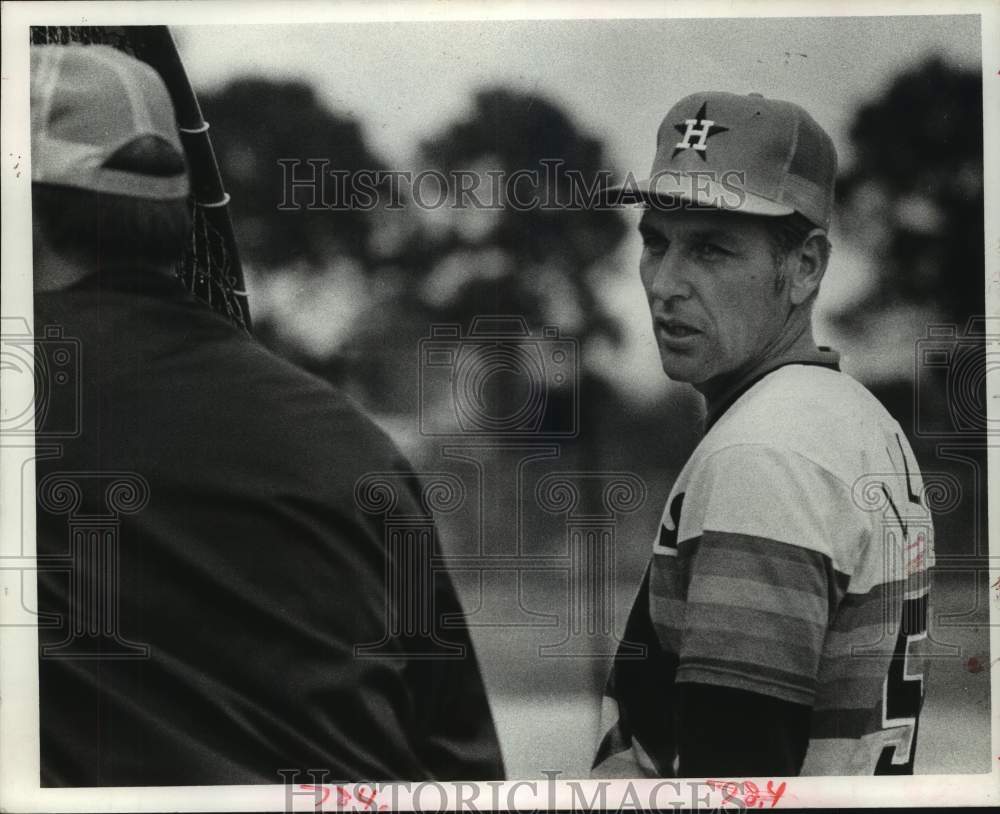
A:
31 45 503 786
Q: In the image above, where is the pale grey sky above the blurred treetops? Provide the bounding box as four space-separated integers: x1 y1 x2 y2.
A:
175 15 980 171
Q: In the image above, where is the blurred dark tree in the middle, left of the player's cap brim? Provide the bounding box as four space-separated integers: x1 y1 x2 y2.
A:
421 87 625 341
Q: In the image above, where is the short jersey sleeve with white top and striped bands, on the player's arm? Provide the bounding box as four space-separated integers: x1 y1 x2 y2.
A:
673 445 864 705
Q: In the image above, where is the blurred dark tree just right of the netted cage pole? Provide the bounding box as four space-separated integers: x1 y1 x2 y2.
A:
201 78 398 384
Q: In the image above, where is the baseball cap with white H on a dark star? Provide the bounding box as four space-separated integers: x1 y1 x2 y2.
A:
608 91 837 230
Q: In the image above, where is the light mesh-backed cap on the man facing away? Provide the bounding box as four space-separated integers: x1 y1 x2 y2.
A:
31 45 189 200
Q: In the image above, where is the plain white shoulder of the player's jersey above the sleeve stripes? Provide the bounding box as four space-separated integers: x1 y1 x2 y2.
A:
674 365 896 574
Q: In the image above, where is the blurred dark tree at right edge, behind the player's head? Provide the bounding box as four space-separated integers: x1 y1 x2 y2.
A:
838 57 984 328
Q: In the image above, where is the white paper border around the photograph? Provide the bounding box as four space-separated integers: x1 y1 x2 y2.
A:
0 0 1000 812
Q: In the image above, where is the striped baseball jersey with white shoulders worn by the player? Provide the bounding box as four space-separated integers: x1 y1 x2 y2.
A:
593 364 933 777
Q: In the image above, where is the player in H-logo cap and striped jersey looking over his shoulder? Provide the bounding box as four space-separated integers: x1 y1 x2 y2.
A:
593 92 933 779
